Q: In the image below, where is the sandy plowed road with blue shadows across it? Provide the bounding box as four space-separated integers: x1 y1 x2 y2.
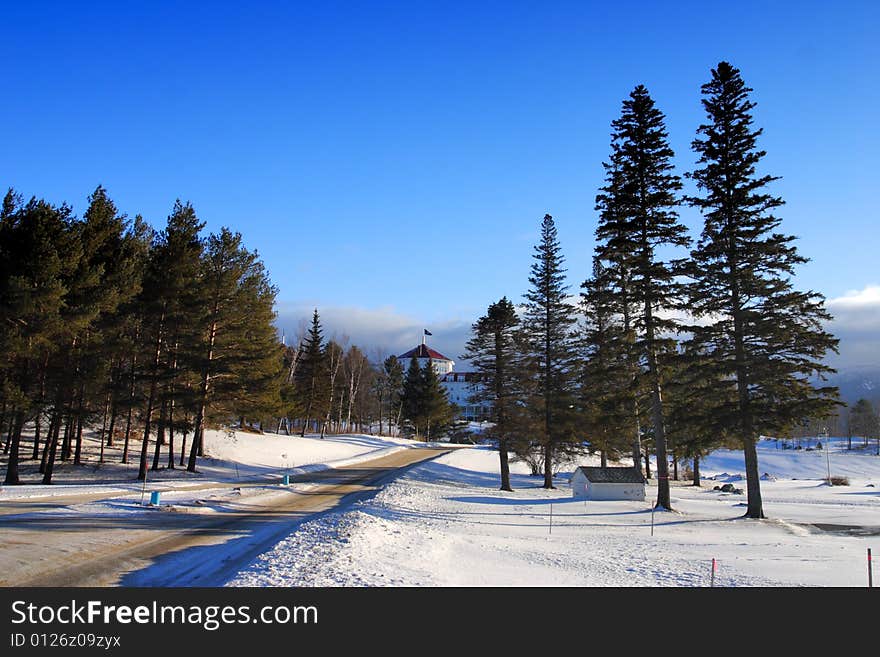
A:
0 448 449 586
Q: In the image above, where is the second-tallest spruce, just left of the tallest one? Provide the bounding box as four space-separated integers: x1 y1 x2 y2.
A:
596 85 690 509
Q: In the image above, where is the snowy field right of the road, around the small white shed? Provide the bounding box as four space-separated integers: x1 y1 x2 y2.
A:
229 441 880 586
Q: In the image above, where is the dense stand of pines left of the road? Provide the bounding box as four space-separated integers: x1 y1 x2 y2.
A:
0 187 282 484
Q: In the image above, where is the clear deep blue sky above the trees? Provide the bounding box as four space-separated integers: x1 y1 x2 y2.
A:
0 1 880 364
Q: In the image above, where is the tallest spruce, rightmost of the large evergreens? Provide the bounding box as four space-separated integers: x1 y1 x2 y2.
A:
688 62 837 518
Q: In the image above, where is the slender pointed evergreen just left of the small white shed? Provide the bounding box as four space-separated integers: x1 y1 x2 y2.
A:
519 214 576 488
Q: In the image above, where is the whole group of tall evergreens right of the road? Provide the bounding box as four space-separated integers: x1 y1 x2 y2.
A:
463 62 838 518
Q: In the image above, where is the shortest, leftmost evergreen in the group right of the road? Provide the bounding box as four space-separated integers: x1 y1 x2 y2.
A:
462 297 520 491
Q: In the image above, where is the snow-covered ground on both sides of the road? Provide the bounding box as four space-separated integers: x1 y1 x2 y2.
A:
0 431 880 586
